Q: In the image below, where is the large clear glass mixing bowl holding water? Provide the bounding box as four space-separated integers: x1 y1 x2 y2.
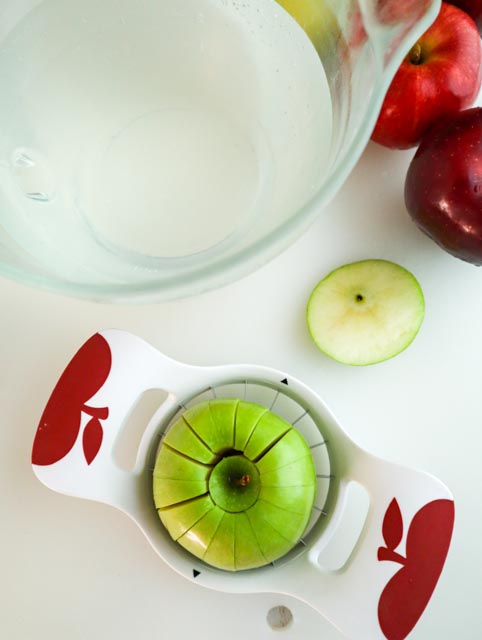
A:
0 0 440 302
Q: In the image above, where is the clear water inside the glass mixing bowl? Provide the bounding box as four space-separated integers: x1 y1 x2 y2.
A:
0 0 332 279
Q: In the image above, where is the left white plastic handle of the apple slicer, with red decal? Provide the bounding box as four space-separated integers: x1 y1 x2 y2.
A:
32 330 199 507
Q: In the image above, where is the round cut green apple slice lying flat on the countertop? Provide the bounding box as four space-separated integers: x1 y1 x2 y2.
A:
306 260 425 365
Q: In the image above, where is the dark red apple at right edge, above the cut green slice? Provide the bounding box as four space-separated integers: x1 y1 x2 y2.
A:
405 107 482 265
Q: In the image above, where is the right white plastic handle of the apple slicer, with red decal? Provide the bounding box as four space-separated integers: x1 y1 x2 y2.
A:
278 445 454 640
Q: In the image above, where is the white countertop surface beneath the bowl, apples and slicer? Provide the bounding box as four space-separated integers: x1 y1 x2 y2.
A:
0 127 482 640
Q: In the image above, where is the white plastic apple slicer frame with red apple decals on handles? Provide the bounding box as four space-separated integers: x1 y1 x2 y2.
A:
32 330 454 640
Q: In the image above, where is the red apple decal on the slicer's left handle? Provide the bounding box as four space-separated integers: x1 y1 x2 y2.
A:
32 334 112 465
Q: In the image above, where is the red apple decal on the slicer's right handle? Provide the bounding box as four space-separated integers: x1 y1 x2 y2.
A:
378 499 455 640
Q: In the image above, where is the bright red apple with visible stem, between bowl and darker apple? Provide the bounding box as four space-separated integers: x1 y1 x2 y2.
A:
372 2 482 149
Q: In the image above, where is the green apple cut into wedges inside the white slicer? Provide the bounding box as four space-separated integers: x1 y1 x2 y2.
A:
153 398 316 571
